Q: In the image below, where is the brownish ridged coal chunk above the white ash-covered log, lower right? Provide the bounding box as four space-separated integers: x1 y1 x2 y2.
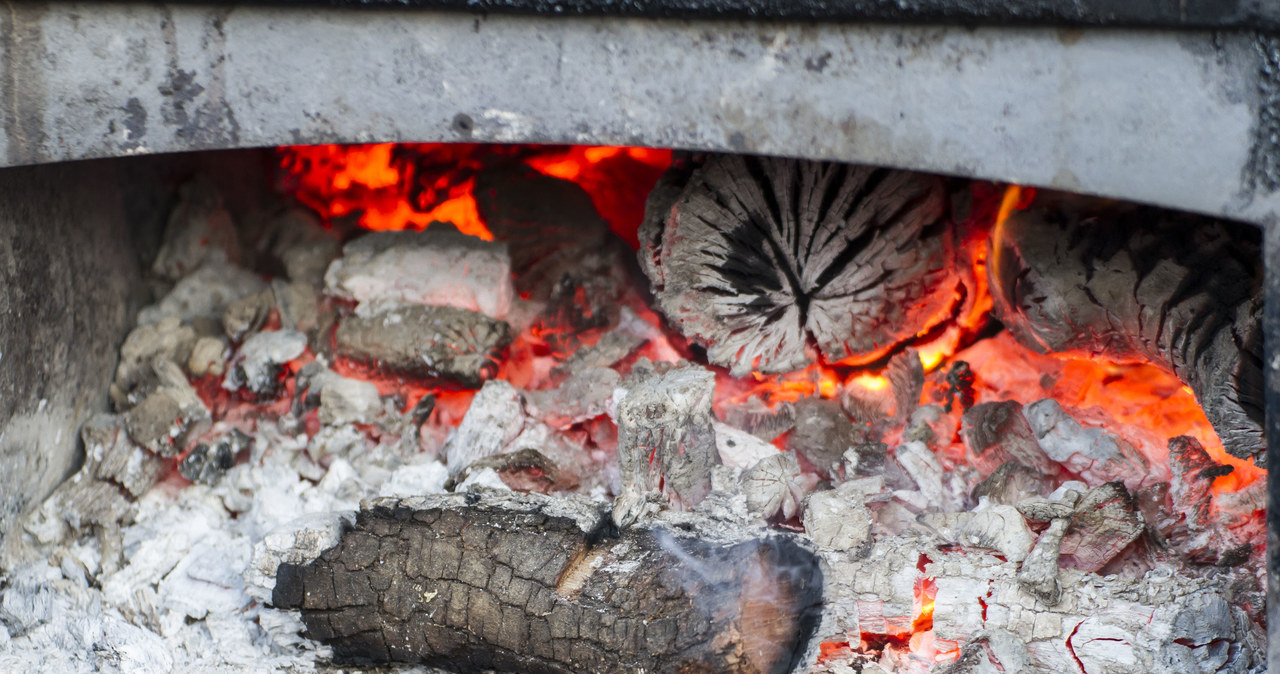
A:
1060 482 1144 573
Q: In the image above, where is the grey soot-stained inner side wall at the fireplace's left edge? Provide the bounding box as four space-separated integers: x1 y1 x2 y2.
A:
0 162 141 555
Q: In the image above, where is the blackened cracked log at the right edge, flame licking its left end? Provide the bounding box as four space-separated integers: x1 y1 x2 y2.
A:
988 197 1265 463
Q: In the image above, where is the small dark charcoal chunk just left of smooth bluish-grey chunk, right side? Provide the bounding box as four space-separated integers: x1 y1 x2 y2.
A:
960 400 1057 476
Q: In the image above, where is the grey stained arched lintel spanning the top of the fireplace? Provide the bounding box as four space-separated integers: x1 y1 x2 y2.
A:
0 3 1280 223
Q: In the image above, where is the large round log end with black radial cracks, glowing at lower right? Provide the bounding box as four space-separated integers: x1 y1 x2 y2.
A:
640 155 959 376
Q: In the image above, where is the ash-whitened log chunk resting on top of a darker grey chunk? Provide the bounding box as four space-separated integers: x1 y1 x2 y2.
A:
325 223 515 318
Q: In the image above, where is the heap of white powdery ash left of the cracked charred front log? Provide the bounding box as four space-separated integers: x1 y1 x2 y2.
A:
0 411 460 673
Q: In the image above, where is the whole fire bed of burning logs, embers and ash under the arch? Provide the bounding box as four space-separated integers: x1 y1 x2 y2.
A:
0 143 1266 673
